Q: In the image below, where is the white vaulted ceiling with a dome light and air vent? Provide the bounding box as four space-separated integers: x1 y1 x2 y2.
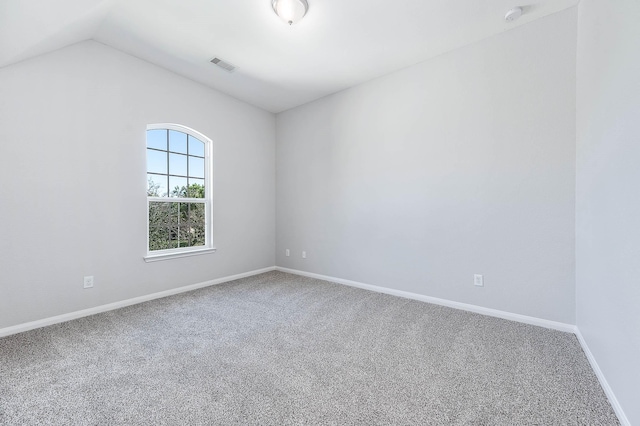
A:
0 0 579 112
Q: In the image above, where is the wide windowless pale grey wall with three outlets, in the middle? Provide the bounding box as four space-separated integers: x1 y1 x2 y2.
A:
276 8 577 324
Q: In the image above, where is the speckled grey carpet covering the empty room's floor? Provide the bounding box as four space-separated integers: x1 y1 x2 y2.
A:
0 272 619 425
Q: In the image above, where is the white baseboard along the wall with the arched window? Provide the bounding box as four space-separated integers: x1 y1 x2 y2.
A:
0 266 275 337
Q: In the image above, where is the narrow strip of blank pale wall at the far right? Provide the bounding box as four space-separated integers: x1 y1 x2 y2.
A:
576 0 640 425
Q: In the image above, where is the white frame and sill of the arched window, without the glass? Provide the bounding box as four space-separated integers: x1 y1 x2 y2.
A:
144 123 216 262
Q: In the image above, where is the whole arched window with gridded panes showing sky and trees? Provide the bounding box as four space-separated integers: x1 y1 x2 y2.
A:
145 124 213 261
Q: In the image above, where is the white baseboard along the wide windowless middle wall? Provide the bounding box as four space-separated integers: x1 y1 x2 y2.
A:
275 266 576 333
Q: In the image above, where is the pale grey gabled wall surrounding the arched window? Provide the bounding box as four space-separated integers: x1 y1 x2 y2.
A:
0 42 275 328
